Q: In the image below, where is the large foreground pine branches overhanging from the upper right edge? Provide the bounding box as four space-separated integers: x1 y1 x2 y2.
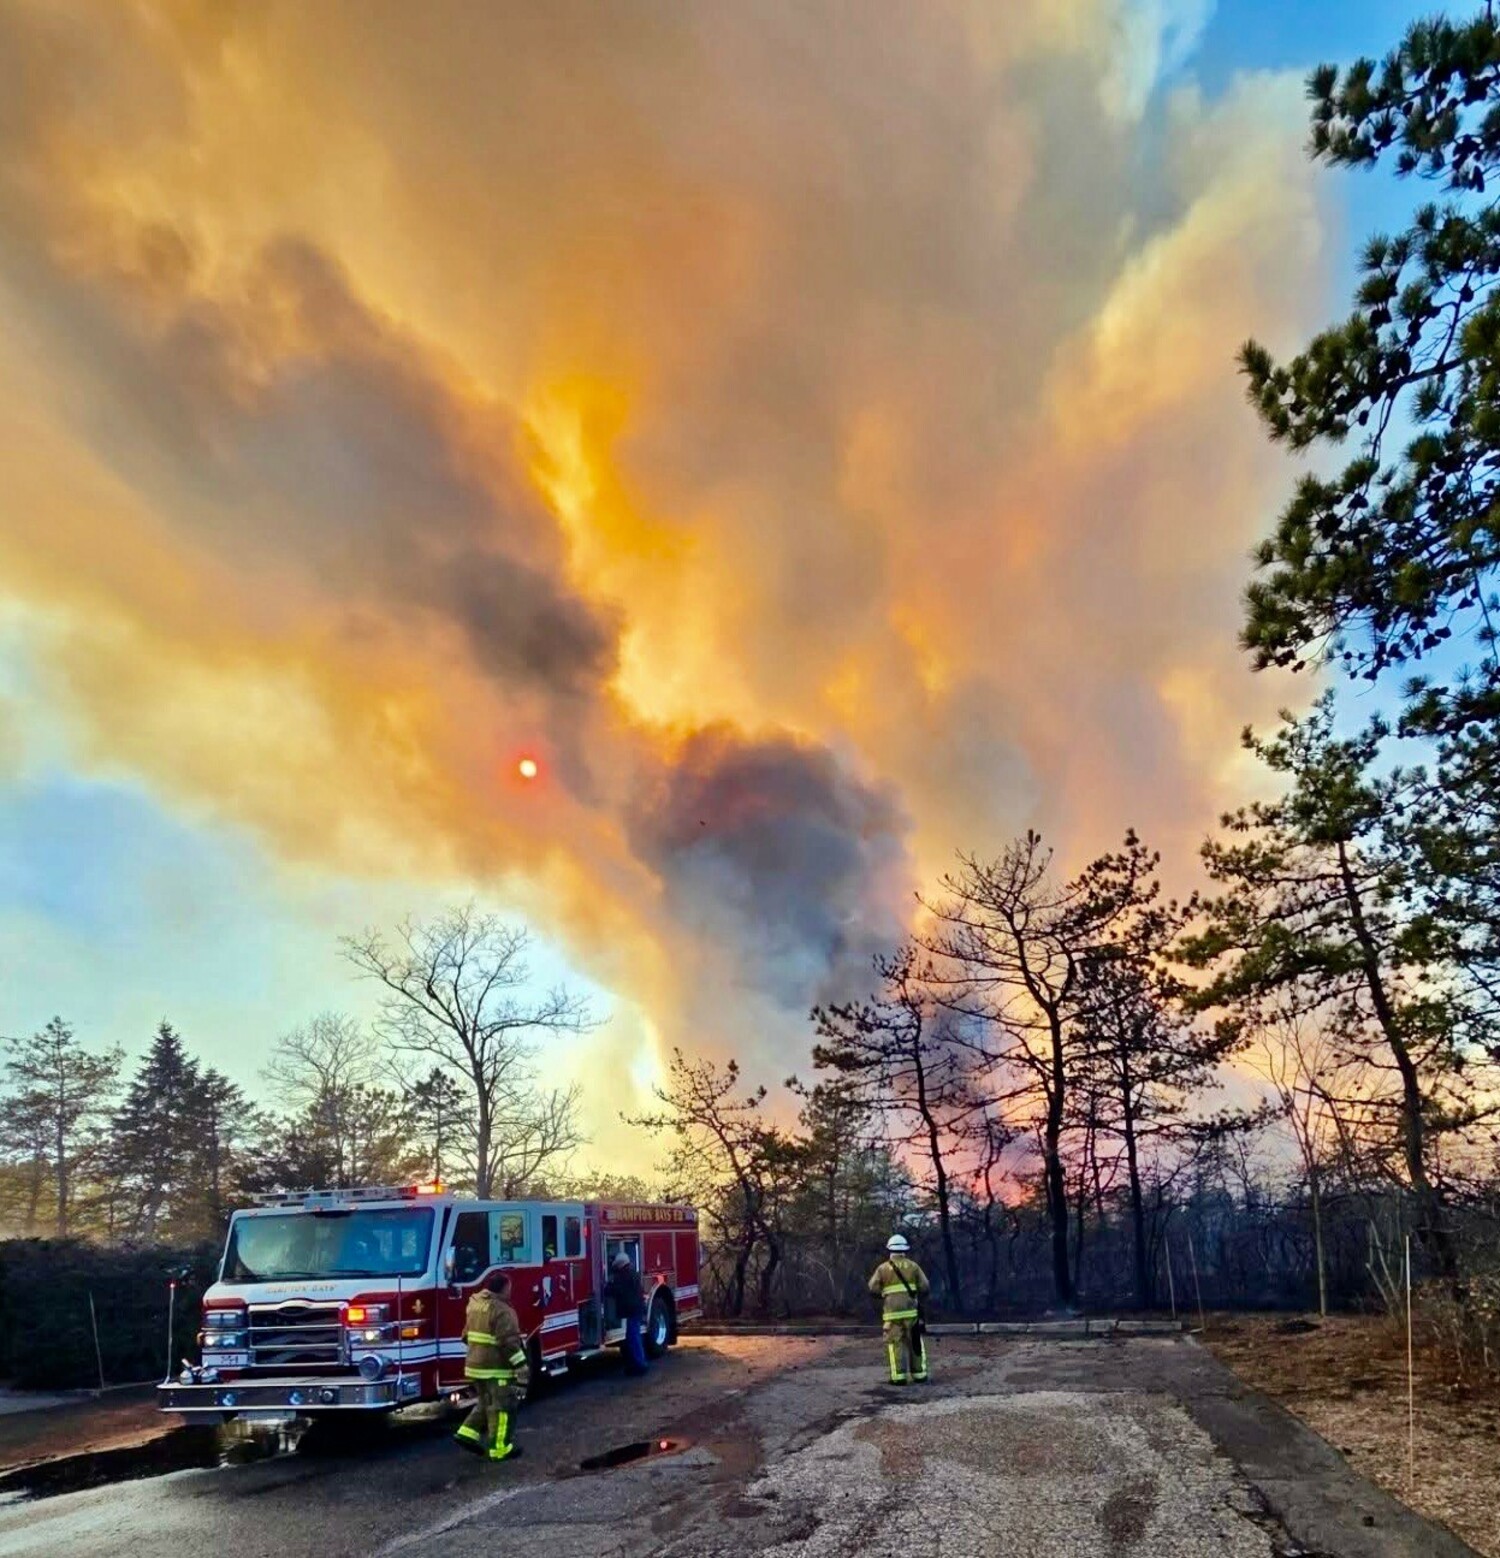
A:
1243 18 1500 1028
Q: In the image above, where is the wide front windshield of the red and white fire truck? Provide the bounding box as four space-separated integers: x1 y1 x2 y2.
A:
223 1206 433 1282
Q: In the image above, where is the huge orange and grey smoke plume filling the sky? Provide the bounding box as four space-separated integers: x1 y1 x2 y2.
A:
0 0 1322 1134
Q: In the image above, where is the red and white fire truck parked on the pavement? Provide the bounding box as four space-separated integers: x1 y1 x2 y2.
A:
157 1184 699 1422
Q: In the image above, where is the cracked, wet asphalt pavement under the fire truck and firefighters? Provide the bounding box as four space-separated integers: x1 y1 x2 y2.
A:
0 1332 1470 1558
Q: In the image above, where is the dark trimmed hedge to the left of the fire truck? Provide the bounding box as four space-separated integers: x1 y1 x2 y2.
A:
0 1239 220 1390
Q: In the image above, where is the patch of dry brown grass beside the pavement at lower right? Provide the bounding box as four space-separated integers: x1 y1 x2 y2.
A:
1206 1315 1500 1558
